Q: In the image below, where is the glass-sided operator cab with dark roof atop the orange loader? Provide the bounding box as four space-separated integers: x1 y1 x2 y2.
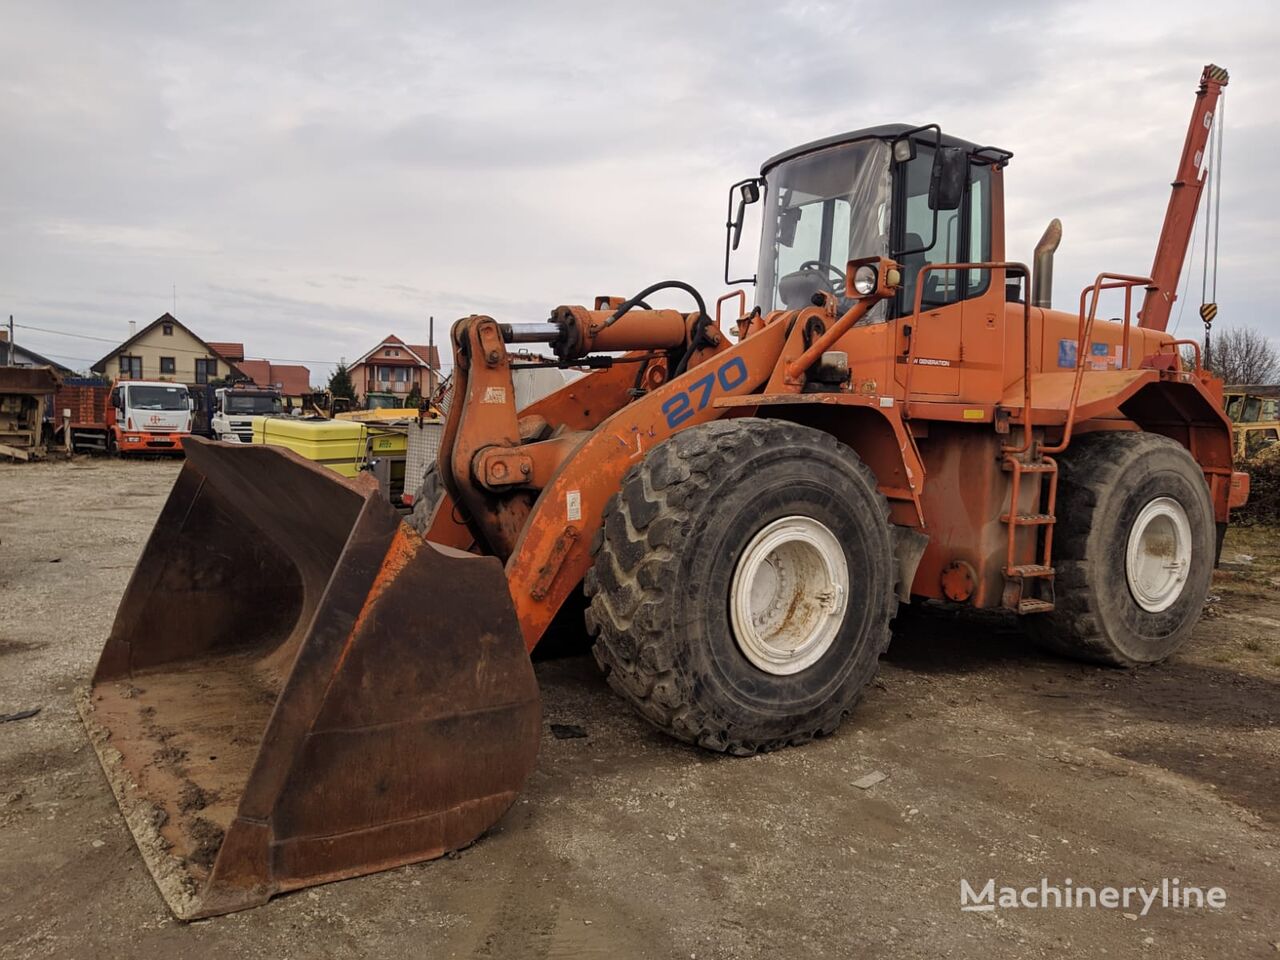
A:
724 124 1012 323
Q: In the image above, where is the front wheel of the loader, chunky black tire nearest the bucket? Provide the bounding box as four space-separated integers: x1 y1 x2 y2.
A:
585 417 897 755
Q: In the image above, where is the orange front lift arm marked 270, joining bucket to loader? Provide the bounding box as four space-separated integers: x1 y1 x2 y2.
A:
426 307 803 649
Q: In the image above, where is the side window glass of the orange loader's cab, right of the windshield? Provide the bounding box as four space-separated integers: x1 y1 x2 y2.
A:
895 145 991 316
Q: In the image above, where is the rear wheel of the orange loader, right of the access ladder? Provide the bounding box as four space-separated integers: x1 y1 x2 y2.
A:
1025 433 1216 667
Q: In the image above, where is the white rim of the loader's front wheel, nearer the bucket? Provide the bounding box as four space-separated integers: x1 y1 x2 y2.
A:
730 516 849 676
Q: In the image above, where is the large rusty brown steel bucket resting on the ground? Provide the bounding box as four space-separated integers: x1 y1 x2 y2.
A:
79 439 540 919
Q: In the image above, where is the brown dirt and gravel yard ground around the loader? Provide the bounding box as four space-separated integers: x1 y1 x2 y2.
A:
0 460 1280 959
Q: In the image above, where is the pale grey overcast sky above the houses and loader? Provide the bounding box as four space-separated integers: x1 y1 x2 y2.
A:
0 0 1280 383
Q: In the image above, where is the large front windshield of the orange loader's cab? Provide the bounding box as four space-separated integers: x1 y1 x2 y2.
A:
756 140 890 321
